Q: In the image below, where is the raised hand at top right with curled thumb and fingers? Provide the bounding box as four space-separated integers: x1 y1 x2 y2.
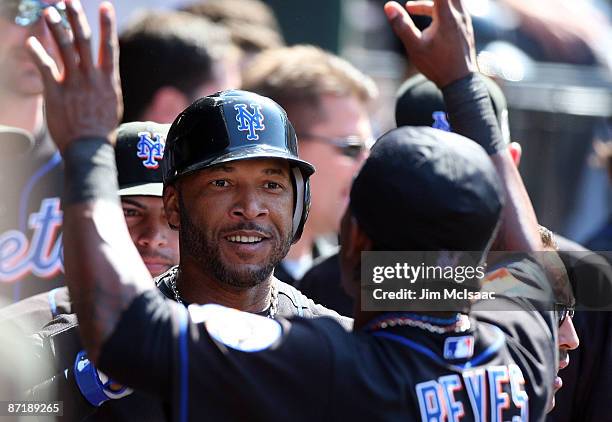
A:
385 0 478 88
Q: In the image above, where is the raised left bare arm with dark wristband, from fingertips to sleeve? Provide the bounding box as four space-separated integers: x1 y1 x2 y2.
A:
28 0 154 362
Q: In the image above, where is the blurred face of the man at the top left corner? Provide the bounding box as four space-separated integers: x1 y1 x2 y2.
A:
0 0 55 96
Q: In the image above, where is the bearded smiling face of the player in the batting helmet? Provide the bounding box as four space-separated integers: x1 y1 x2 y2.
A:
170 159 293 288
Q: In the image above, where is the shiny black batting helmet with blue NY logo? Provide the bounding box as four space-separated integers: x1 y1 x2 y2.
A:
162 90 315 242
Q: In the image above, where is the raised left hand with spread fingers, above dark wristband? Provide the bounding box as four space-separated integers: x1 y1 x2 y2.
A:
27 0 123 152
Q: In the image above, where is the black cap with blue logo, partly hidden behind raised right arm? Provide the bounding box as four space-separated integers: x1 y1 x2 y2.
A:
395 74 510 143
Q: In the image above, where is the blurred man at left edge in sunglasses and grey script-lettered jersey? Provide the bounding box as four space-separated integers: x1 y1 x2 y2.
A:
0 0 65 302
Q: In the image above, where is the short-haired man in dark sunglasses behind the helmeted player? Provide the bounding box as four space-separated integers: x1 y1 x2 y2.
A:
243 45 376 284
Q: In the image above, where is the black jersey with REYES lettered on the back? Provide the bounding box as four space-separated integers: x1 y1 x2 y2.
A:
99 258 556 421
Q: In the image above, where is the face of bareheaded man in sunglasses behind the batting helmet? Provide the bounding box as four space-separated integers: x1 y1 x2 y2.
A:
298 95 372 235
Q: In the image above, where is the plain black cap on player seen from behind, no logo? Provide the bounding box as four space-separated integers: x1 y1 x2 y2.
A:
350 127 503 251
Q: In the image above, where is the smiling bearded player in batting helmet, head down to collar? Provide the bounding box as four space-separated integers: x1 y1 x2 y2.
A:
157 90 350 327
